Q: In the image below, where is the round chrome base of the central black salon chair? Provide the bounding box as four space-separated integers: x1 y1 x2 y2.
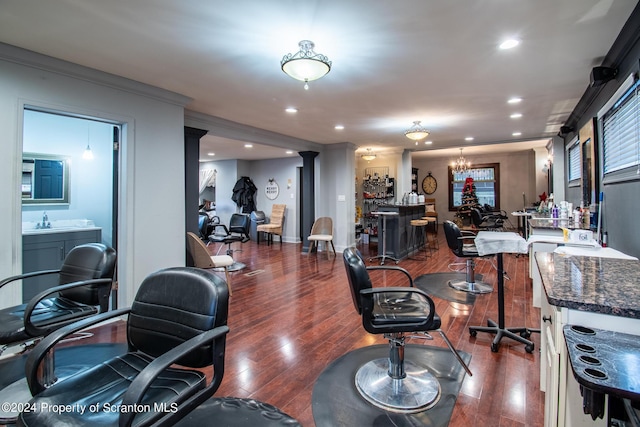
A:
355 358 441 413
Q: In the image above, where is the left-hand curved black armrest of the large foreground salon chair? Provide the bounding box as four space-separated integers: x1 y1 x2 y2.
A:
24 308 131 396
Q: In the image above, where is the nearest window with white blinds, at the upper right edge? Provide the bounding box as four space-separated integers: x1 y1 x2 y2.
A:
600 76 640 183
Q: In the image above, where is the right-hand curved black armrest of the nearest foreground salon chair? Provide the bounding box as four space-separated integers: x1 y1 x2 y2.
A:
119 325 229 426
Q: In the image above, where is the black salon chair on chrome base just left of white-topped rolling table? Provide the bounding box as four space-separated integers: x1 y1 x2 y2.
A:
443 221 493 294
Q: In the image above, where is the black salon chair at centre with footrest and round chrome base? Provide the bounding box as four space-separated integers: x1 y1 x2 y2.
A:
343 248 472 413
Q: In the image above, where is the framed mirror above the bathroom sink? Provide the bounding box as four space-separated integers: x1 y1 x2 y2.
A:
21 153 70 205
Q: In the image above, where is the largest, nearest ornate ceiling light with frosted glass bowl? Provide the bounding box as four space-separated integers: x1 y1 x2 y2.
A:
280 40 331 90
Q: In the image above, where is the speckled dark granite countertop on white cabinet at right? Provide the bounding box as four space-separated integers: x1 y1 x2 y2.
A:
535 252 640 319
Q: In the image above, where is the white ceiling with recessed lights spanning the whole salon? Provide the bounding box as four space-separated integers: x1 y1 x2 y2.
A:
0 0 637 160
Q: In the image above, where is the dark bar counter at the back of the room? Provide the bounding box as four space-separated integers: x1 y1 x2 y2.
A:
377 203 425 259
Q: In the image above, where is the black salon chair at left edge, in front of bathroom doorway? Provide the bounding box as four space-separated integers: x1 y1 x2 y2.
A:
0 243 116 354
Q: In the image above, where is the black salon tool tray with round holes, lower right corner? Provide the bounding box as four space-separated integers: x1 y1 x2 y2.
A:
563 325 640 400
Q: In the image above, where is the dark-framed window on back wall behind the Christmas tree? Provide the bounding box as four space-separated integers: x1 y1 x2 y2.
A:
449 163 500 211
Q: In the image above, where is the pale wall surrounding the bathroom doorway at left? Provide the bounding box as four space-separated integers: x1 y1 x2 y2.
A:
0 44 188 306
